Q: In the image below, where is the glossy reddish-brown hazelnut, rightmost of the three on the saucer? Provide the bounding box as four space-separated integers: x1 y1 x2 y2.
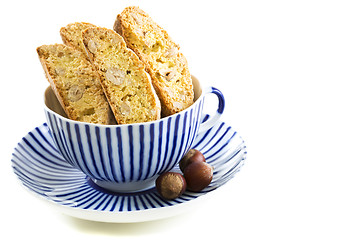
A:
184 162 213 192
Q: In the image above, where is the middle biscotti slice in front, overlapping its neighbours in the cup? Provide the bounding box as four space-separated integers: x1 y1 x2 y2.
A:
83 27 161 124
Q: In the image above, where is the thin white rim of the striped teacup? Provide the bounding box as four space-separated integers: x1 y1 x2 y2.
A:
43 75 205 128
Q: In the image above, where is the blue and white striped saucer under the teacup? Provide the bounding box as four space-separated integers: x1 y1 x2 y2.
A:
12 115 247 223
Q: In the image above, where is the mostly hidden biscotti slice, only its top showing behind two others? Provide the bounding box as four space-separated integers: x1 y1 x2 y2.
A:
60 22 96 58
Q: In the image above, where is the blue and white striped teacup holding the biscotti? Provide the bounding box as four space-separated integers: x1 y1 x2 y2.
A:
45 77 225 192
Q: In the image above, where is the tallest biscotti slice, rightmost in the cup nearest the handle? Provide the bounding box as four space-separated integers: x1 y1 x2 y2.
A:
114 7 194 116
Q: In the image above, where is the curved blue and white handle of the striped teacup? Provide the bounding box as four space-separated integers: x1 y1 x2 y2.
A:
198 87 225 133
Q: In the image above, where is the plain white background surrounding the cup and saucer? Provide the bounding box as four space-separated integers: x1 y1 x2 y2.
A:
0 0 360 239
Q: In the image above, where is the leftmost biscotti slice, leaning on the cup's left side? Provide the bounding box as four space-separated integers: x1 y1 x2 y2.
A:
36 44 113 124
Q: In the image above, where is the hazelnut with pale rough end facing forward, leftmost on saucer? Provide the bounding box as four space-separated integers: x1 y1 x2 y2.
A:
155 172 186 200
